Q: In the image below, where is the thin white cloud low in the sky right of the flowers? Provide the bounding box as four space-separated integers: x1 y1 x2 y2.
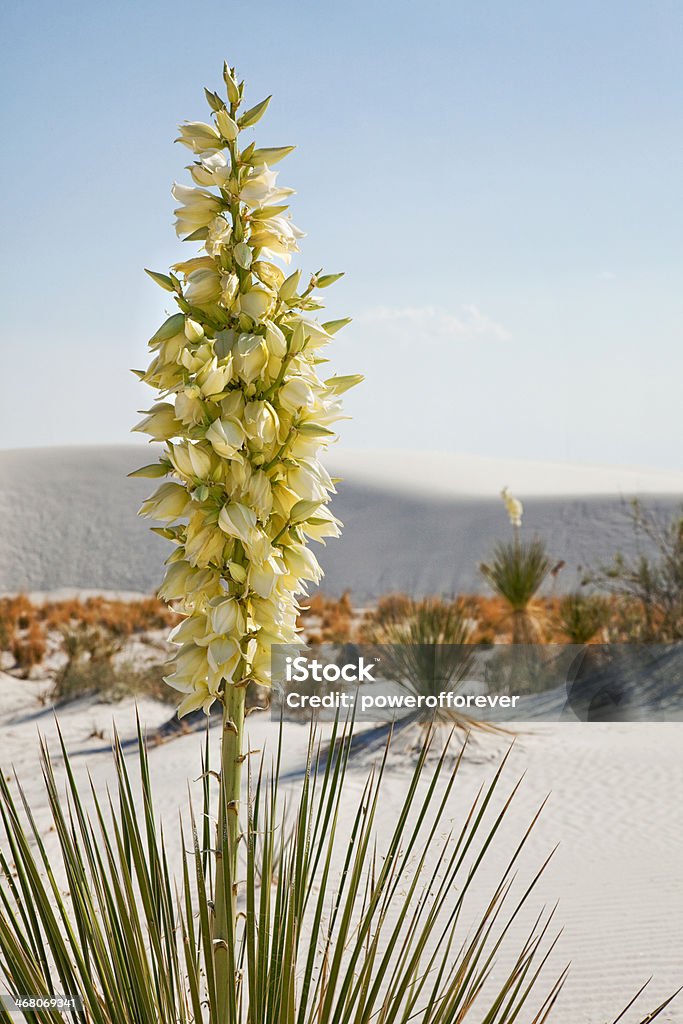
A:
356 305 512 341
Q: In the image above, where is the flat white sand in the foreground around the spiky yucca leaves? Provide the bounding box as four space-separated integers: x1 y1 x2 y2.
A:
0 674 683 1024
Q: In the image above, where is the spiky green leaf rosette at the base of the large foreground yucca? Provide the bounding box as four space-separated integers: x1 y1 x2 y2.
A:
0 725 667 1024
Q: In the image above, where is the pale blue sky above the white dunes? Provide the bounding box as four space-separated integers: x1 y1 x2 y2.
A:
0 0 683 468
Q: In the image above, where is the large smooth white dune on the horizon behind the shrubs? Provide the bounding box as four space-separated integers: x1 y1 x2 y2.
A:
0 445 683 603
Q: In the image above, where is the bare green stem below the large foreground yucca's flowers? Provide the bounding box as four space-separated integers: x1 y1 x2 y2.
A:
213 685 247 1024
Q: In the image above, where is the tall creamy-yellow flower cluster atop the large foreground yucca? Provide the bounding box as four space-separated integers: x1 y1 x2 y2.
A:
131 66 361 715
